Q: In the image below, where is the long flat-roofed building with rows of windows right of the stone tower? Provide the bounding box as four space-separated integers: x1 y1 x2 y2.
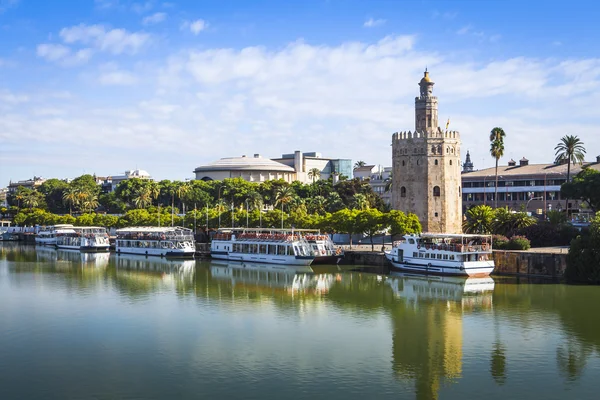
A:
462 157 600 214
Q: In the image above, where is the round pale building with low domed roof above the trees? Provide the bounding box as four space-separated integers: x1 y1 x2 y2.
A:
194 154 296 183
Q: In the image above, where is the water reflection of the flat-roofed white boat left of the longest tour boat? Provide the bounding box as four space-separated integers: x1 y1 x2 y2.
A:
115 254 196 276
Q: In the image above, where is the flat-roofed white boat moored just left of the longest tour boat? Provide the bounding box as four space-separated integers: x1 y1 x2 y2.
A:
115 226 196 258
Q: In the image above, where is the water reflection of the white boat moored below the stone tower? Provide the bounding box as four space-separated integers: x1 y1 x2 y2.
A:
386 273 494 305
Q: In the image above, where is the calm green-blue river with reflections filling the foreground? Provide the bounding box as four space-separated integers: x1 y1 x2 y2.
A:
0 243 600 400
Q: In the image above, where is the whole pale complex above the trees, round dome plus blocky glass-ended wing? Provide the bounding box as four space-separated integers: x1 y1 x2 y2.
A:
194 151 352 183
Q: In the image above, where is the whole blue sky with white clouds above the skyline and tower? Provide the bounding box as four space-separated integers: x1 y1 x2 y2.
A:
0 0 600 187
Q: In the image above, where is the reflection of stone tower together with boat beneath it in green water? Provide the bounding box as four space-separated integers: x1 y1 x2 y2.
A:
388 276 494 399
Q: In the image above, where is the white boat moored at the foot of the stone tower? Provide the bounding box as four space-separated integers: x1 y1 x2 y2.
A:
385 233 494 276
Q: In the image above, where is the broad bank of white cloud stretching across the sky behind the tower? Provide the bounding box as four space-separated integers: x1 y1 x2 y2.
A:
0 36 600 181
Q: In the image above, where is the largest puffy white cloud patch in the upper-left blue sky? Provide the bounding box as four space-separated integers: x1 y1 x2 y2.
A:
60 24 150 54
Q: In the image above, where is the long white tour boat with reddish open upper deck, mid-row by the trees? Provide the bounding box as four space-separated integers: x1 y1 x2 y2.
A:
210 228 315 265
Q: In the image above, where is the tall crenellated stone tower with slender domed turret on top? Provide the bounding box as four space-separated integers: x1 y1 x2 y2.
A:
392 70 462 233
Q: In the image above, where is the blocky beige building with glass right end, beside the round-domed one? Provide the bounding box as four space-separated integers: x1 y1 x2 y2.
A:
273 150 352 183
